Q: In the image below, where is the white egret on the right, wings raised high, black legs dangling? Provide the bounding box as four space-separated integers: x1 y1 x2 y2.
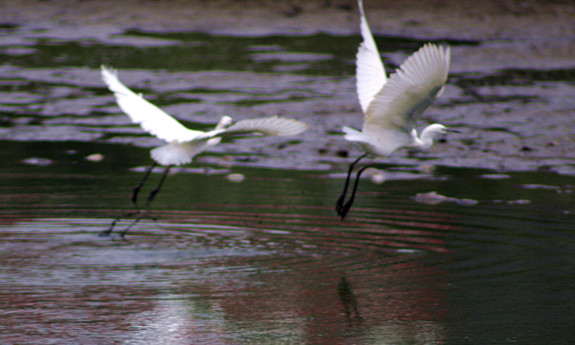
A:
336 0 452 219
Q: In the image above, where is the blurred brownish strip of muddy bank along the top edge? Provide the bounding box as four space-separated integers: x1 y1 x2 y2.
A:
0 0 575 43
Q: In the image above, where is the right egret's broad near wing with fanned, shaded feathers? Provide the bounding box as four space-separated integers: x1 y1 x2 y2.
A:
364 43 450 133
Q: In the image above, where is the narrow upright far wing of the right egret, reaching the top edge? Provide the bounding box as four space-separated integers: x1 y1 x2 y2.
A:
356 0 387 114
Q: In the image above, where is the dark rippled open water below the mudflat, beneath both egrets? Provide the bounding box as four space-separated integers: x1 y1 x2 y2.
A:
0 138 575 344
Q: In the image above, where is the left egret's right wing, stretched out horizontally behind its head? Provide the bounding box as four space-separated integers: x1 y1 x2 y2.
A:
197 116 308 140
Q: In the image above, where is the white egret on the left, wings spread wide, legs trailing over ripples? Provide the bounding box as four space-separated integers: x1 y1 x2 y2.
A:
102 66 307 233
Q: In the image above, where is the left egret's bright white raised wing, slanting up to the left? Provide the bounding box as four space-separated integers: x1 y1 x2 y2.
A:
102 66 203 142
